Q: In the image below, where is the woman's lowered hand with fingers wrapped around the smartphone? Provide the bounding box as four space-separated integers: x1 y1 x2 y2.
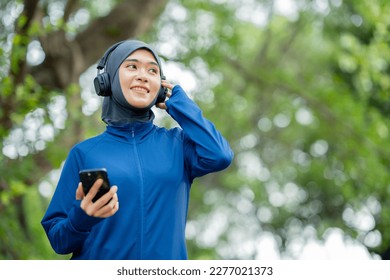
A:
76 179 119 218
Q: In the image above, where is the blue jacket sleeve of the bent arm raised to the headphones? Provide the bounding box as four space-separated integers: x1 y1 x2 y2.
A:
166 85 233 180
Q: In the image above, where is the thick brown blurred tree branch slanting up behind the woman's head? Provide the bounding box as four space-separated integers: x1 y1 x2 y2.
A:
32 0 167 89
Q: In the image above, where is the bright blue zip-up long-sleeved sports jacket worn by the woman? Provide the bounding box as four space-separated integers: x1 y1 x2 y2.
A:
42 85 233 260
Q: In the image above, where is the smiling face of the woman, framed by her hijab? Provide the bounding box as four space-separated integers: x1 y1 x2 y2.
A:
119 49 161 108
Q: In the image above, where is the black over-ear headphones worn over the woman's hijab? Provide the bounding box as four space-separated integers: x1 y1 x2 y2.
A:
93 41 168 104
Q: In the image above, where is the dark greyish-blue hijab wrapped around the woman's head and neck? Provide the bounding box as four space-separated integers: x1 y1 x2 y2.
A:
102 40 162 125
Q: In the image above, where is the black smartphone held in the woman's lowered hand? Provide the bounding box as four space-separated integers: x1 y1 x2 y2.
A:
79 168 110 202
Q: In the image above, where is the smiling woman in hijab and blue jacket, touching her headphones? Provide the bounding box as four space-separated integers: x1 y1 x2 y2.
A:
42 40 233 259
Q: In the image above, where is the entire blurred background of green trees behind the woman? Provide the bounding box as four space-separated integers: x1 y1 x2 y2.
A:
0 0 390 260
